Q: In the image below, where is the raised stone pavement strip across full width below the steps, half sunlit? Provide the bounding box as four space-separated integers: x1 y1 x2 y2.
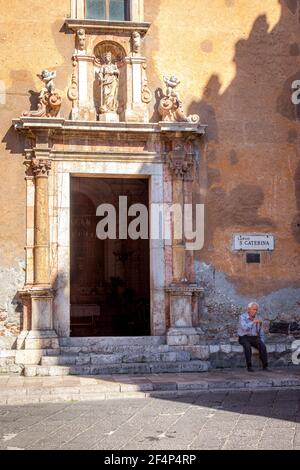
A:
0 367 300 405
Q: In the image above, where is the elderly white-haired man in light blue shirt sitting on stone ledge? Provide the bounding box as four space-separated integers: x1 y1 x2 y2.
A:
238 302 268 372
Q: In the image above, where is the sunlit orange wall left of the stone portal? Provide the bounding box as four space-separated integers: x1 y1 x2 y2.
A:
0 0 74 340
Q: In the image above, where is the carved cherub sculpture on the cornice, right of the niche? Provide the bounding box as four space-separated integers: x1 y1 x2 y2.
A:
158 75 200 123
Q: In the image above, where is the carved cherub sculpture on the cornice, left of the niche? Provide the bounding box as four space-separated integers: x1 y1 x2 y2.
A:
23 70 62 117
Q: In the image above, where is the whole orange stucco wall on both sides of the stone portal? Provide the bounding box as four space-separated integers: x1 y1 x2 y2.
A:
0 0 300 346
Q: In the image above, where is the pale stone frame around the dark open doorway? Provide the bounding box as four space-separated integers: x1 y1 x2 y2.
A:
49 161 166 337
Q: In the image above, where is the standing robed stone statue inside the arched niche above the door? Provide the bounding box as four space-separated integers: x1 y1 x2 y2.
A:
98 52 120 114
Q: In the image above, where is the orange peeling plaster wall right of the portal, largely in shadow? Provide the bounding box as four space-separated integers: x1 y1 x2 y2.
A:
145 0 300 340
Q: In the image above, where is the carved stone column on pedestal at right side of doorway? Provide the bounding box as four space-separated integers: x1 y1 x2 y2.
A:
166 139 203 346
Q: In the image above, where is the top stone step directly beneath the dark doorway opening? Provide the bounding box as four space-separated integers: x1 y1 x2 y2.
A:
59 336 166 350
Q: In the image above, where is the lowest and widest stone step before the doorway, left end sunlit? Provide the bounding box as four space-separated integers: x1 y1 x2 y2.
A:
24 361 210 377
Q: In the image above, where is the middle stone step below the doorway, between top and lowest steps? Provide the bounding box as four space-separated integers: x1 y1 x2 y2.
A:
41 351 191 366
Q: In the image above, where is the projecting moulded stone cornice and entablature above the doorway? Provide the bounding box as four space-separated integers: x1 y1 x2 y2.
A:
13 116 206 164
